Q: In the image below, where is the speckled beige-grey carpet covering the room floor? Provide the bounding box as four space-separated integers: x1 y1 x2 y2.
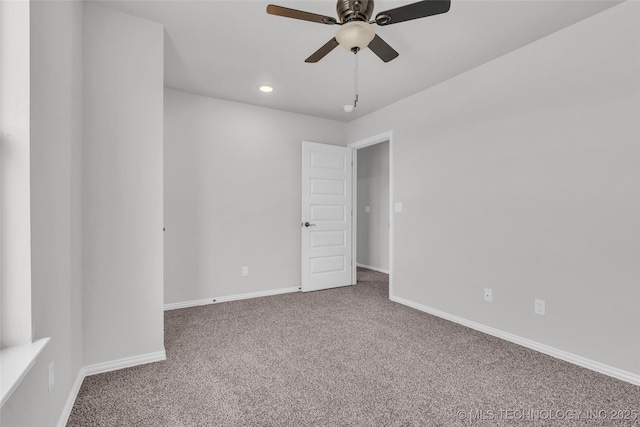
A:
68 270 640 426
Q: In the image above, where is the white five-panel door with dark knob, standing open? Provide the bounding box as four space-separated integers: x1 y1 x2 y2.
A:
301 141 353 292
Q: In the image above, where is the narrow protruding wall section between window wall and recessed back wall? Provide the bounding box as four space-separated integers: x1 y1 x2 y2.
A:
83 4 164 366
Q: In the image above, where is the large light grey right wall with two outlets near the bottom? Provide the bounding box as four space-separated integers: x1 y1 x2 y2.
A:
347 2 640 375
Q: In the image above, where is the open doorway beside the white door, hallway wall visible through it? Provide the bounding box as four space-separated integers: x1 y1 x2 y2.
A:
348 132 393 297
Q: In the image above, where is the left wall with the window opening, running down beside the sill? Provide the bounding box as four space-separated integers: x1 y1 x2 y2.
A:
1 1 82 427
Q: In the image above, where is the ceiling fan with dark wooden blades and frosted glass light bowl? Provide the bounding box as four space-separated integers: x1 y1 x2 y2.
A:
267 0 451 63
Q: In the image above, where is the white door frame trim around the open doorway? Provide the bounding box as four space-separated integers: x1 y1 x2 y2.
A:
347 130 394 297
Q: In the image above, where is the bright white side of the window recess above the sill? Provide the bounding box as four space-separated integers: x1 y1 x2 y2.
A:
0 2 32 348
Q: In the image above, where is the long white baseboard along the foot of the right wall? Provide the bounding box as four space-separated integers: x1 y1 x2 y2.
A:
389 295 640 385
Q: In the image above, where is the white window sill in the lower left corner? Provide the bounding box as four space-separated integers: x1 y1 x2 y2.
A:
0 338 50 407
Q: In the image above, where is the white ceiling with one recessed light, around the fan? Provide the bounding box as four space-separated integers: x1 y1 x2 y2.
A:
95 0 618 122
